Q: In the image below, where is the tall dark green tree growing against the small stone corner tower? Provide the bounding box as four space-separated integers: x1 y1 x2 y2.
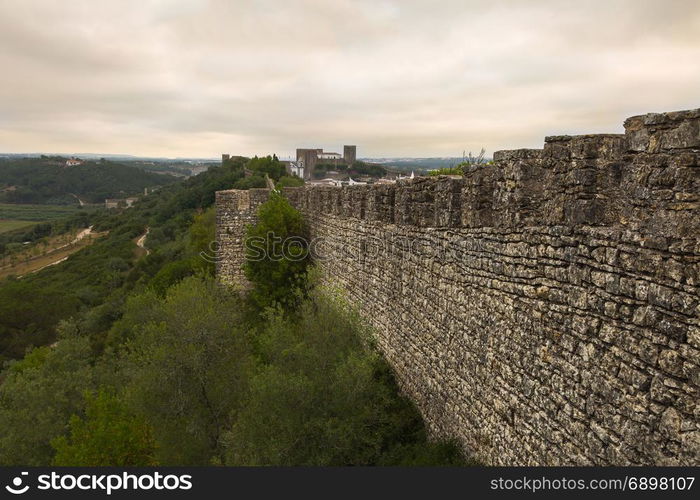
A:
244 191 309 308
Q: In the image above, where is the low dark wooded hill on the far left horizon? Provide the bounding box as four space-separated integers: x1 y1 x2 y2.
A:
0 156 175 205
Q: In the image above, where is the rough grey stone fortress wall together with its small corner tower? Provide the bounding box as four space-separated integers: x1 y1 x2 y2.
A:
217 110 700 465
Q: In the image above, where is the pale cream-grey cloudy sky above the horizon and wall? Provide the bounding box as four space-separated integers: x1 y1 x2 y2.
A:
0 0 700 157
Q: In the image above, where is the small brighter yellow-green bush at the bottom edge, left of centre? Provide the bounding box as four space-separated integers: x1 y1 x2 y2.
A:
51 390 156 467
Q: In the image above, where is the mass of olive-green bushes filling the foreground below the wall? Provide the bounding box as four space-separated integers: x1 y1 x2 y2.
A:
0 277 462 465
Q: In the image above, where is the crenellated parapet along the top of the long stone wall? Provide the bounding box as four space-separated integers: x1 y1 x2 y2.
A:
276 112 700 237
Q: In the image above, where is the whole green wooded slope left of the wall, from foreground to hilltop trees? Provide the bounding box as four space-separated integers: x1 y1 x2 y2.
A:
0 157 465 466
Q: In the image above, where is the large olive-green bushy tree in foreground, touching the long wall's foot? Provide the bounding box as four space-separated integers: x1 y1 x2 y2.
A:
224 291 461 465
